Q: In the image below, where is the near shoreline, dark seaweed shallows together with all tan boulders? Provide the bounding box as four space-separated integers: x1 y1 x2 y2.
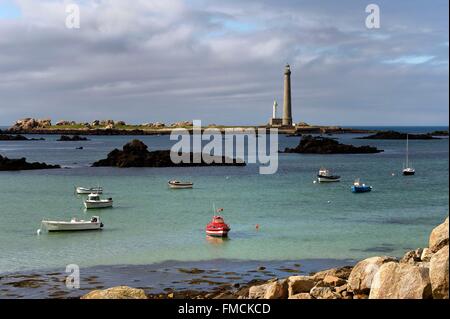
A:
0 217 449 299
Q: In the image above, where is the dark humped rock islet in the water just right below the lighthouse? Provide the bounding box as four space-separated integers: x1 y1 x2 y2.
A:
284 135 383 154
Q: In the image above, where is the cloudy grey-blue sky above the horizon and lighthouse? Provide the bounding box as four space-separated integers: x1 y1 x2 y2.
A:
0 0 449 126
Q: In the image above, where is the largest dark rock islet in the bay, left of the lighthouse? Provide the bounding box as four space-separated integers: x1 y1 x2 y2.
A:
93 140 245 167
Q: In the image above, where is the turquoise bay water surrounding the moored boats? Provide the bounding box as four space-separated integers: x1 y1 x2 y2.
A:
0 130 449 273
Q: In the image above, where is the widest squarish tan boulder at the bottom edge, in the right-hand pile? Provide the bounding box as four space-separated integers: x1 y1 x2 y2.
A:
369 262 432 299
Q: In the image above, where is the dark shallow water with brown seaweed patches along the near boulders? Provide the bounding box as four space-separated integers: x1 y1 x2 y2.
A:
0 259 355 299
